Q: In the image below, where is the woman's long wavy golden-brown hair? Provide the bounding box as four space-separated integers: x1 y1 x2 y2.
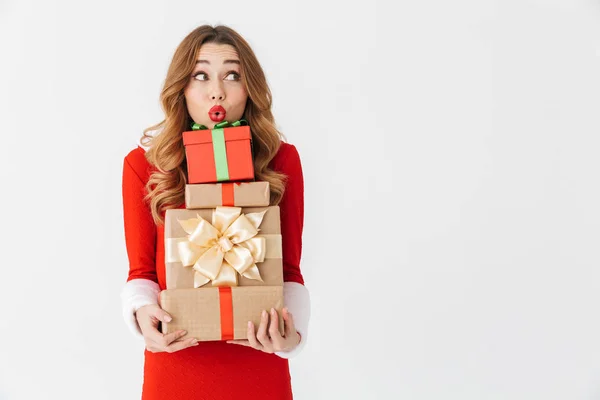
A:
140 25 286 225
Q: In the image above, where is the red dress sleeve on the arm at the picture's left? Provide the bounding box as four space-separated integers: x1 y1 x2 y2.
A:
123 157 158 282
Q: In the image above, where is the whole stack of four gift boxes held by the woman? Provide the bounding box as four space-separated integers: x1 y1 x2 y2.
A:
160 120 283 341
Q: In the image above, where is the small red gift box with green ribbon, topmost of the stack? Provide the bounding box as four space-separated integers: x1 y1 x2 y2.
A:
182 119 254 184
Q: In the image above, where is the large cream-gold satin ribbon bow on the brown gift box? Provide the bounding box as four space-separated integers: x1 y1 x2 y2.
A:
169 207 267 288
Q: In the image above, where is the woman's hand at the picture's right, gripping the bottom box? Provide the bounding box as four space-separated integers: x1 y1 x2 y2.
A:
227 308 300 354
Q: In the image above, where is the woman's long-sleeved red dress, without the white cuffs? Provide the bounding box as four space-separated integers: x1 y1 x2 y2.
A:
123 142 304 400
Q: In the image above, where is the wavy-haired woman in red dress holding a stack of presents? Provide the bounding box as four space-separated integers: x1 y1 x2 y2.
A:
121 25 310 400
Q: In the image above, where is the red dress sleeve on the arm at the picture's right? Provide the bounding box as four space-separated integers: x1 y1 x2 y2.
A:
279 145 304 285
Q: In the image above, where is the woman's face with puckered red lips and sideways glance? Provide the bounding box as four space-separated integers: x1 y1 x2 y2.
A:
184 43 248 129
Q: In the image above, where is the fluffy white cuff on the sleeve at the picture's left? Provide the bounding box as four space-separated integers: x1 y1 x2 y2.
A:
121 279 160 339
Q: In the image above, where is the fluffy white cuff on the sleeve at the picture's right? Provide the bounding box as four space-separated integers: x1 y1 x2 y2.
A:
275 282 310 358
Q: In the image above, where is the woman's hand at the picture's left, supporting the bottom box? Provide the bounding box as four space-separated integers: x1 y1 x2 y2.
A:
135 304 198 353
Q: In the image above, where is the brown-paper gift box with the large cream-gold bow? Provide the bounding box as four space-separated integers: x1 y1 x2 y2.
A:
164 206 283 289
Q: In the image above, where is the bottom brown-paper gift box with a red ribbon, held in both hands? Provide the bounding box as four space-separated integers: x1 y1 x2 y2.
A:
160 286 284 341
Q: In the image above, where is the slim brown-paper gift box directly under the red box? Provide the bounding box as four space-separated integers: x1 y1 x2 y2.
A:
185 181 271 209
